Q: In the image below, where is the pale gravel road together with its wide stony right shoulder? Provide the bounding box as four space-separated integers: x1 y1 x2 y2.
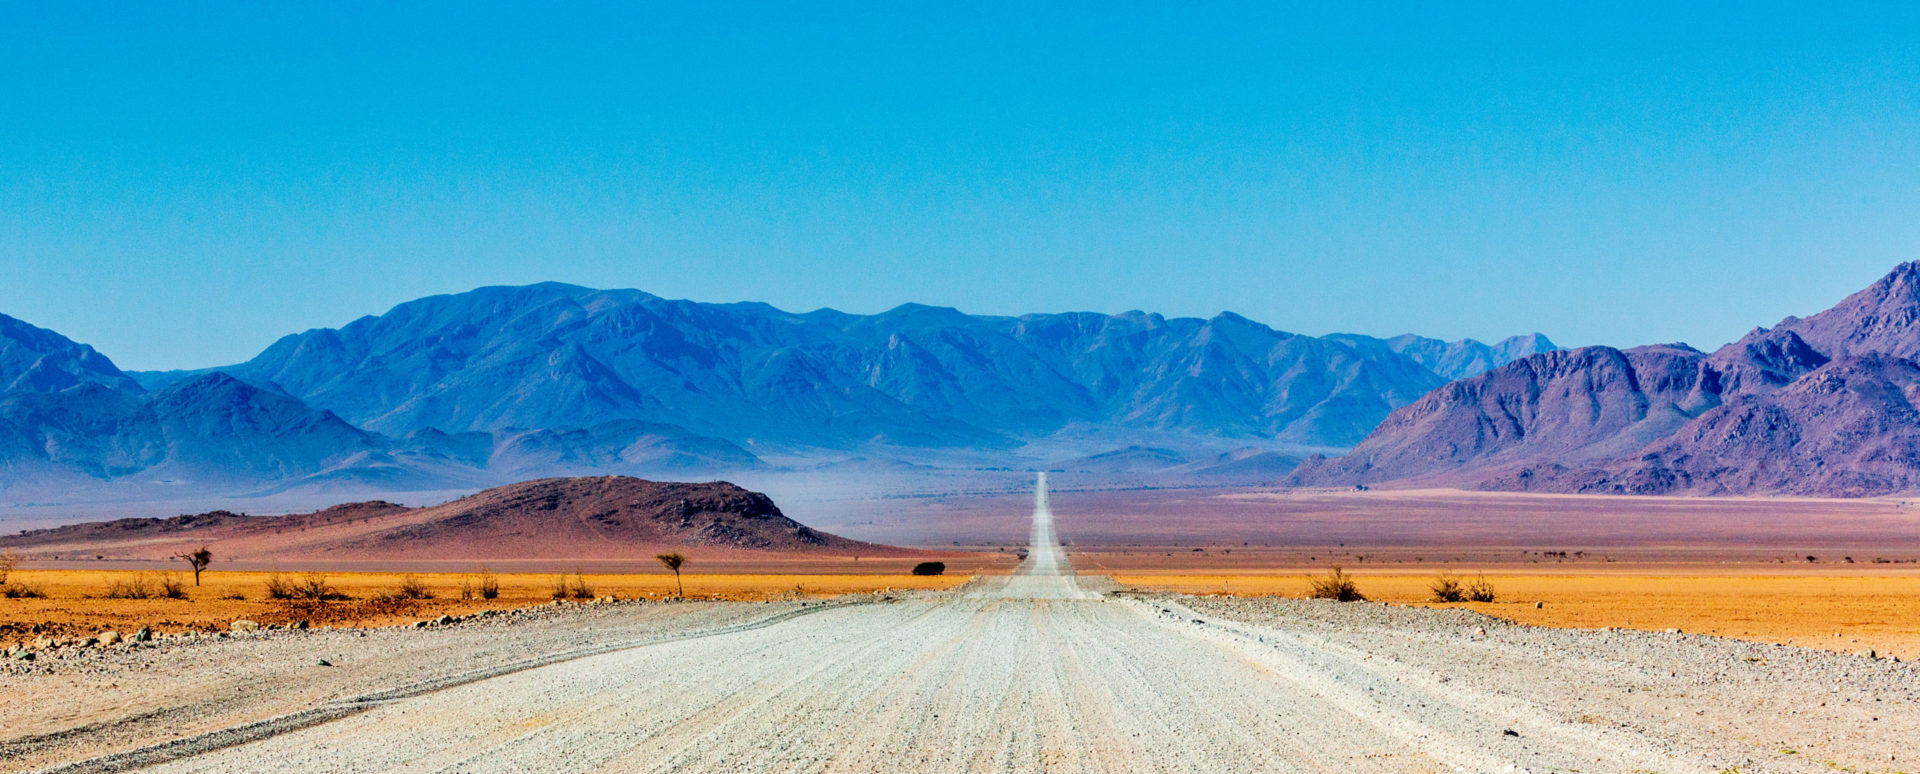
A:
18 476 1920 772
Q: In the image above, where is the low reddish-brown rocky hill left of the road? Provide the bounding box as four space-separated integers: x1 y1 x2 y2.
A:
0 476 890 563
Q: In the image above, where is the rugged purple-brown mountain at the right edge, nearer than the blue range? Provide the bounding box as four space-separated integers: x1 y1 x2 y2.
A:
1292 263 1920 496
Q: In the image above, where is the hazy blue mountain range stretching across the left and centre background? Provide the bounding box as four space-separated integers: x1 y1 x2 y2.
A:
0 284 1551 503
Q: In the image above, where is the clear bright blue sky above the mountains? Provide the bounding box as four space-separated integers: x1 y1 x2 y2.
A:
0 0 1920 369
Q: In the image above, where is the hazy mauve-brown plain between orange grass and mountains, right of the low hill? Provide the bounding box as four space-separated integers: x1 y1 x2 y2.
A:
808 483 1920 572
